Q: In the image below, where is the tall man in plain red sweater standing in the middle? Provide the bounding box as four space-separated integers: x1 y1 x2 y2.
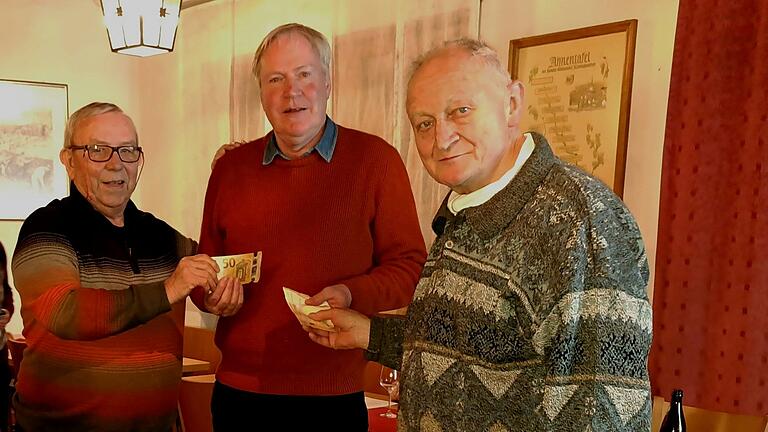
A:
193 24 426 432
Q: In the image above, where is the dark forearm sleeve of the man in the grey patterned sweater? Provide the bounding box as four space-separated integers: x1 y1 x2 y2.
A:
365 315 406 370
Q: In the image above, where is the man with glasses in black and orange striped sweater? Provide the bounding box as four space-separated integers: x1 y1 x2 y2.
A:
13 102 237 432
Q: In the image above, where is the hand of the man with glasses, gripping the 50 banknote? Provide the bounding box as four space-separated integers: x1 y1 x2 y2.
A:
164 254 219 304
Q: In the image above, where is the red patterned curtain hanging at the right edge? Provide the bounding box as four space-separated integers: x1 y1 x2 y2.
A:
649 0 768 415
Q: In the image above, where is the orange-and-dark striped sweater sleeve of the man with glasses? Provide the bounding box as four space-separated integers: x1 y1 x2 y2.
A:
12 228 171 340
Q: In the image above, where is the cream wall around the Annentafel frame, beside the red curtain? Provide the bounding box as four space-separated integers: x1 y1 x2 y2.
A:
480 0 678 292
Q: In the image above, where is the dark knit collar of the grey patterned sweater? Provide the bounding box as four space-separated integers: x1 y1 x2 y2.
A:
432 132 560 239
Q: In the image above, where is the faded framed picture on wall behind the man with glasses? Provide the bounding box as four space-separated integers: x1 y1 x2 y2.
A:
0 79 69 220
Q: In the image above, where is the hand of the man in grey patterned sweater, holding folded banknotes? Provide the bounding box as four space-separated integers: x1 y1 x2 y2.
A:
303 308 371 349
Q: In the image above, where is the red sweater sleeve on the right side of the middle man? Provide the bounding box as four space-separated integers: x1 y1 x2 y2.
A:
339 145 427 315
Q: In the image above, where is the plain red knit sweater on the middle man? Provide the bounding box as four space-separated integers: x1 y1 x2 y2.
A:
192 127 426 395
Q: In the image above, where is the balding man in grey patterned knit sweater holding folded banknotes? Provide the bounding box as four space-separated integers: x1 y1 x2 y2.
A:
308 40 651 432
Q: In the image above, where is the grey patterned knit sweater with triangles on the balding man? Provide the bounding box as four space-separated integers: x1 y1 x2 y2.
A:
367 135 651 432
